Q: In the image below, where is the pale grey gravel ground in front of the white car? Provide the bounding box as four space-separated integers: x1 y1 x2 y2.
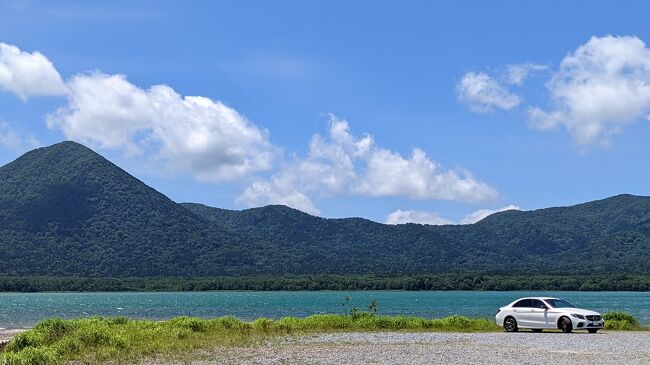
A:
181 332 650 365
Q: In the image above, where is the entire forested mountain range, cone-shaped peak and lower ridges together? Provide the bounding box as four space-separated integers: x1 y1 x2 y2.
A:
0 142 650 277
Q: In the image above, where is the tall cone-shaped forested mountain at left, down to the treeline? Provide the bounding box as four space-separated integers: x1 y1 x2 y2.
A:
0 142 266 276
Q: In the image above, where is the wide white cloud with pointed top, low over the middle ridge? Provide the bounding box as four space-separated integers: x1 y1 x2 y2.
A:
237 116 498 214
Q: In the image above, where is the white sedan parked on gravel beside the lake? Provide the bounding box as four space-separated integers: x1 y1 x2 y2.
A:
496 297 605 333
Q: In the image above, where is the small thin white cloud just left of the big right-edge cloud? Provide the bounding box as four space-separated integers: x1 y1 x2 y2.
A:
456 72 523 113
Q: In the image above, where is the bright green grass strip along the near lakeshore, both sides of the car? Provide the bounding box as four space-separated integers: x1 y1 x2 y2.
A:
0 310 636 365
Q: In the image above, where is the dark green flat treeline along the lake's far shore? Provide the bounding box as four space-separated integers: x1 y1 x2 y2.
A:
0 273 650 292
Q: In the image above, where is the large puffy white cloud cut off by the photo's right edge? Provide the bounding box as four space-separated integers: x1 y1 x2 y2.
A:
529 36 650 144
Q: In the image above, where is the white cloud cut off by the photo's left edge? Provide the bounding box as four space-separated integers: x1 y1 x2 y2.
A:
0 43 66 100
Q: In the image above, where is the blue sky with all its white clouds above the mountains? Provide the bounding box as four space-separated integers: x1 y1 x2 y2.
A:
0 0 650 224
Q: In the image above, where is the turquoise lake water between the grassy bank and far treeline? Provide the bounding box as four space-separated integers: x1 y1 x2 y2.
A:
0 291 650 328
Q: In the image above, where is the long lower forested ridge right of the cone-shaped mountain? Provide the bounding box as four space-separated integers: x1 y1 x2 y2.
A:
183 195 650 274
